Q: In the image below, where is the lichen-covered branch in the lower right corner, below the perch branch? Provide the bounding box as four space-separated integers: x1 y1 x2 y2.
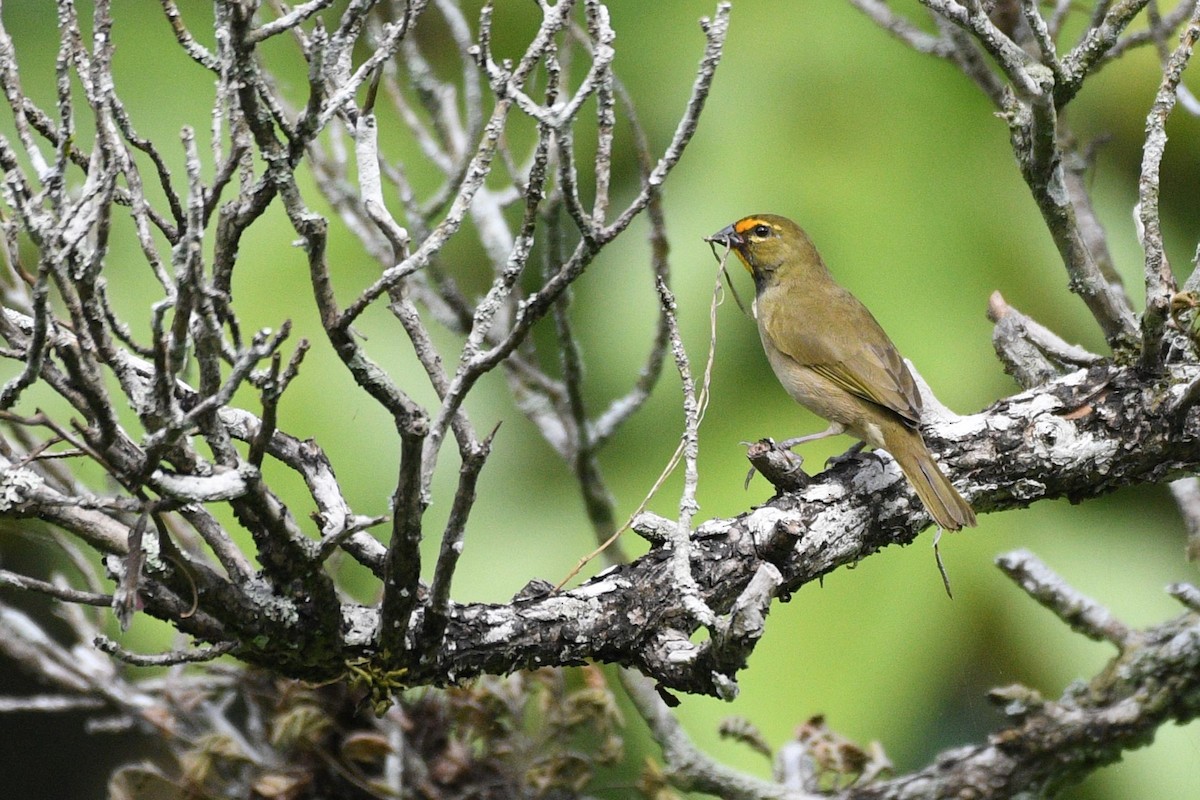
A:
840 553 1200 800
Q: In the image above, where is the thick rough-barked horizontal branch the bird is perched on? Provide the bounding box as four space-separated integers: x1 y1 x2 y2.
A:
350 365 1200 694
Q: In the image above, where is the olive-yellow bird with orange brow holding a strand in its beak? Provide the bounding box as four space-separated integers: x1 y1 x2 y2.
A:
706 213 976 530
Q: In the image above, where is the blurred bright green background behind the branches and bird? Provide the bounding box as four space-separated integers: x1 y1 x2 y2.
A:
0 0 1200 800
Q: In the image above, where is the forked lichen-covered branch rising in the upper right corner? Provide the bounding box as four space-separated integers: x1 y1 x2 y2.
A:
852 0 1194 350
